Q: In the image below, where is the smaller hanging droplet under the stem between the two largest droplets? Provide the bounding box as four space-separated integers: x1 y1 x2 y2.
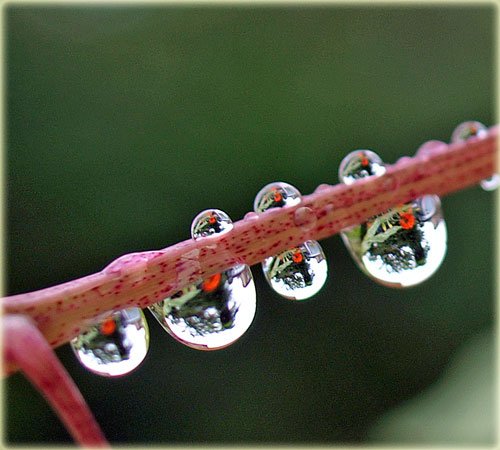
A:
262 241 328 300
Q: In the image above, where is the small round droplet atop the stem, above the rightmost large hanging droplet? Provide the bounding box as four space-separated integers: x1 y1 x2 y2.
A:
339 150 386 184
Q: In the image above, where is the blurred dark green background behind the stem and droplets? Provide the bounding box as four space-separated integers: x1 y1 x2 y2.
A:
3 3 496 445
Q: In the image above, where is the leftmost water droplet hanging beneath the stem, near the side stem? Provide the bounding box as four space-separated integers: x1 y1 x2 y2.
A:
70 308 149 377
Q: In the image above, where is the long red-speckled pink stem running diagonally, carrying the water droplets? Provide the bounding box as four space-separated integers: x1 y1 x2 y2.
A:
2 127 498 358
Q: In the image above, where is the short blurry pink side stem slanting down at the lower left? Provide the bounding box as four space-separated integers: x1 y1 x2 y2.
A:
2 315 109 447
